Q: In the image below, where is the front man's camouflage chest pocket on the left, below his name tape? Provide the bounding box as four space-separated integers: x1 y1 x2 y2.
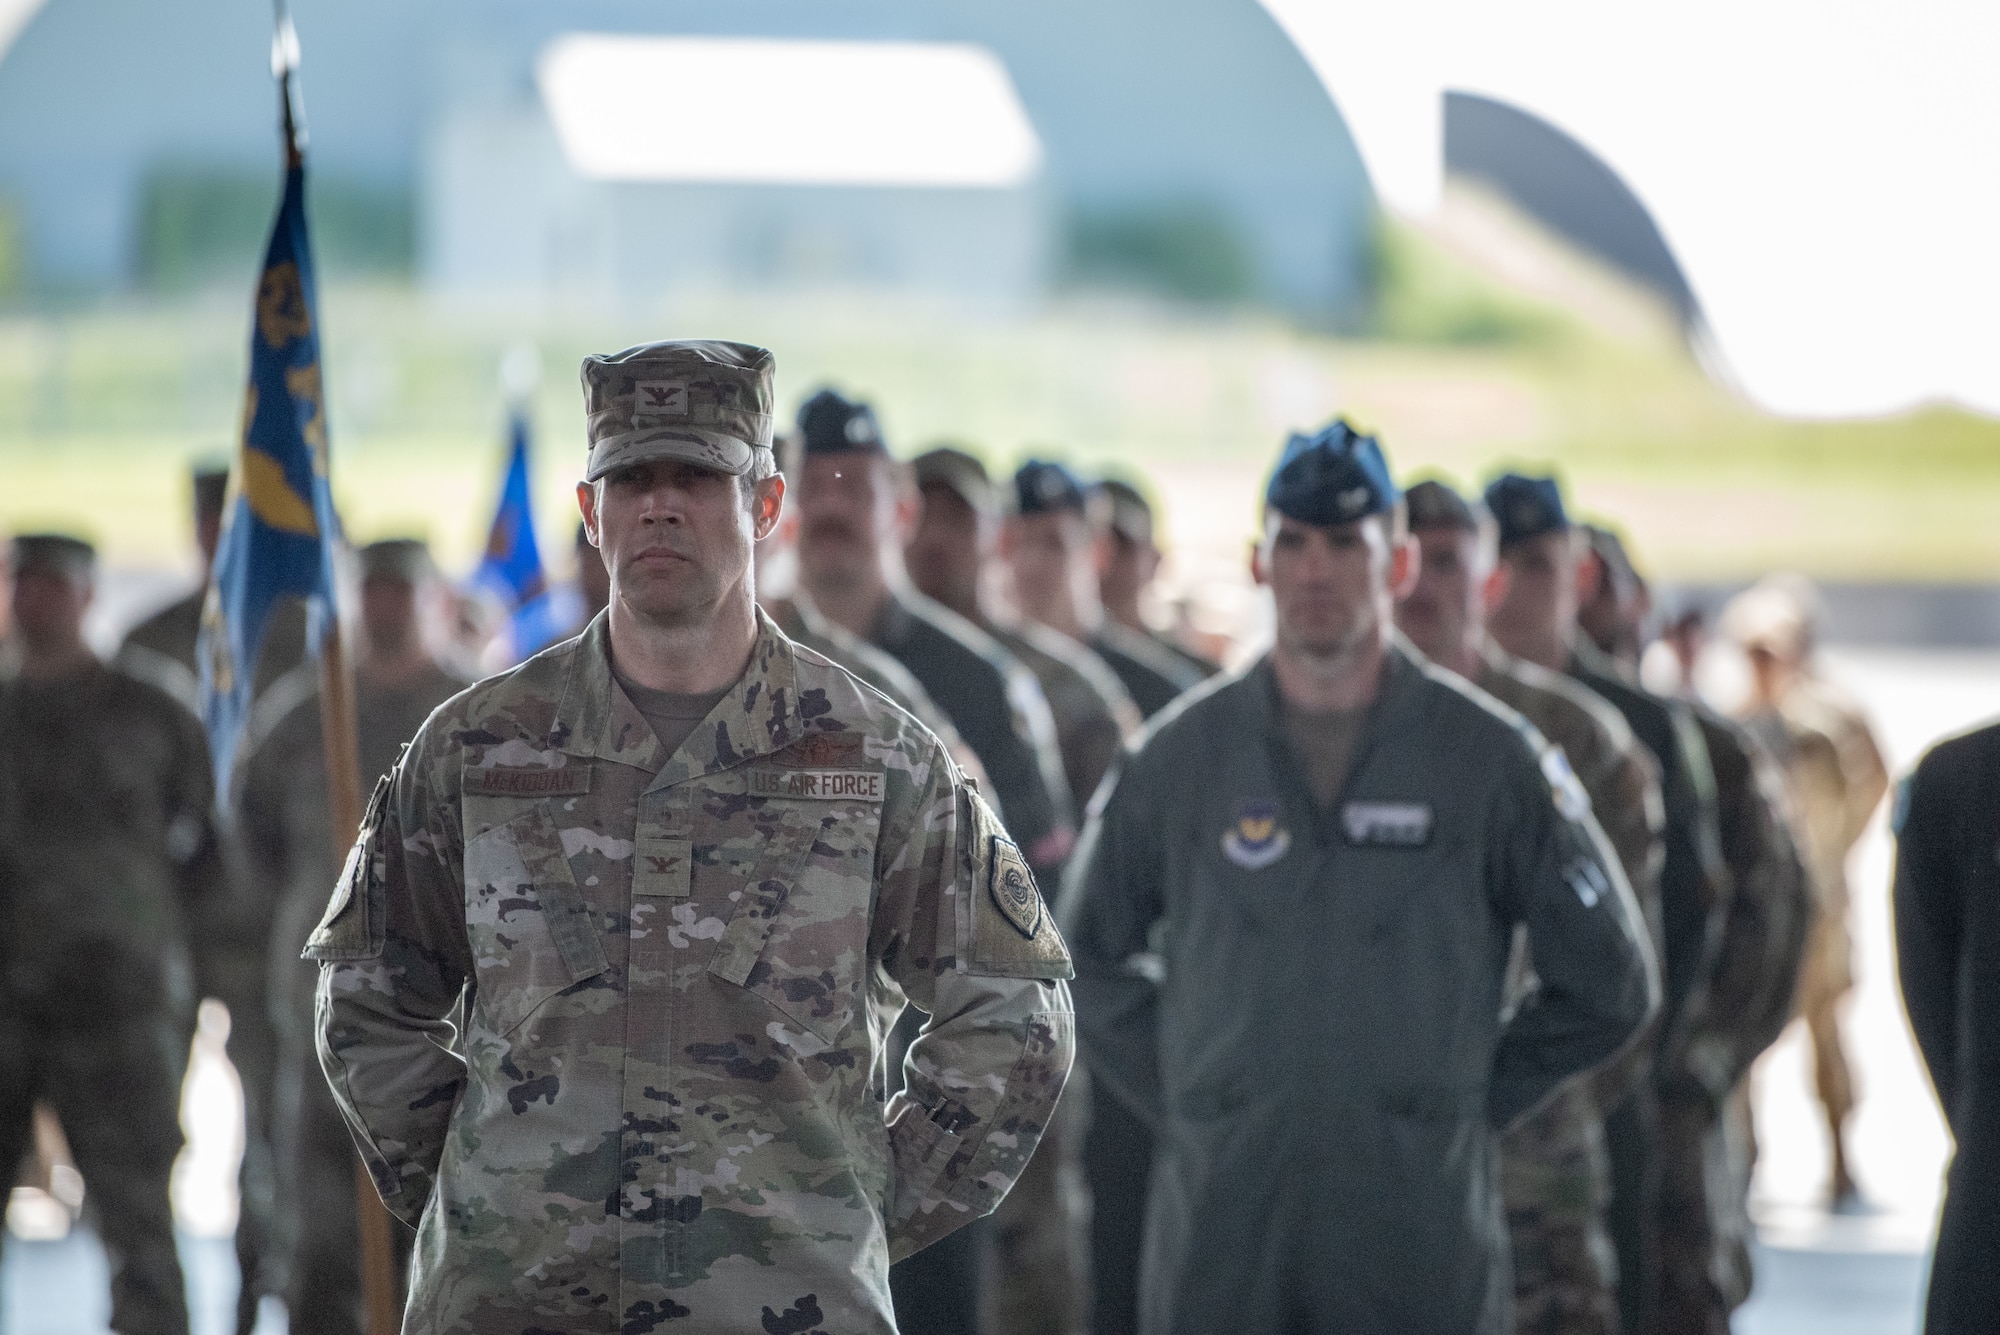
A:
466 801 610 1037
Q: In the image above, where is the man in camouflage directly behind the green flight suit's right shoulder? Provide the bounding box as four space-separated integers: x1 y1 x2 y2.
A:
1396 482 1664 1335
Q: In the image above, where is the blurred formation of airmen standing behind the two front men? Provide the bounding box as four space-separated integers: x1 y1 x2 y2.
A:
0 367 1912 1335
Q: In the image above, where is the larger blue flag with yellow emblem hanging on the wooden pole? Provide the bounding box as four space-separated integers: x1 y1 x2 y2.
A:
196 117 340 791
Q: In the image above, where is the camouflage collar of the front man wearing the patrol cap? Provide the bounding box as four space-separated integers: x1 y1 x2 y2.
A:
554 608 816 787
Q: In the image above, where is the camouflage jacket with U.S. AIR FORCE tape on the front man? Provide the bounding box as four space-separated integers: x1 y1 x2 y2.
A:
306 616 1074 1333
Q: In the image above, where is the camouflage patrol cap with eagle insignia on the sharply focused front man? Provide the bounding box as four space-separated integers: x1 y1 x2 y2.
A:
582 340 776 482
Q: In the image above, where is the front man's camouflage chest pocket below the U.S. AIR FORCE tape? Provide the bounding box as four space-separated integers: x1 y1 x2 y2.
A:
694 799 882 1055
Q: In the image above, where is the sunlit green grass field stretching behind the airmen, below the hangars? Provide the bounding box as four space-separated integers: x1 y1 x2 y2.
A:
0 249 2000 580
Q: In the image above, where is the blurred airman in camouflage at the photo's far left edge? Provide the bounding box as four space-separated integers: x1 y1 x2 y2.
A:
0 536 230 1335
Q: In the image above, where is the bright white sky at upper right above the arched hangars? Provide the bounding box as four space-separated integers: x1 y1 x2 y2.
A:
0 0 2000 416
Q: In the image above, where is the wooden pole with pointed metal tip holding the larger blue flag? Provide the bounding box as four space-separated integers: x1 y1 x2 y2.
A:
272 0 402 1335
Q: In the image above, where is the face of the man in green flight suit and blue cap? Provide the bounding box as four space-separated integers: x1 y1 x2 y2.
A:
1256 514 1412 660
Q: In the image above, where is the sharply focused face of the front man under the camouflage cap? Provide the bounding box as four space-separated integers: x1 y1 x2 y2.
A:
576 460 784 626
